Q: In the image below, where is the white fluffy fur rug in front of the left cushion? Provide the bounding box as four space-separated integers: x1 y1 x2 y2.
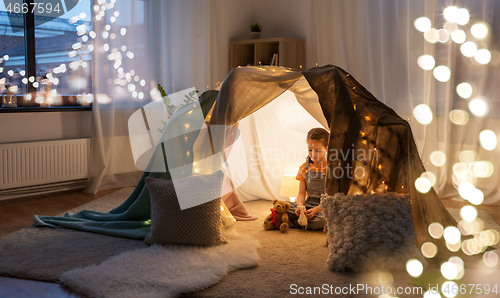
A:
61 233 260 298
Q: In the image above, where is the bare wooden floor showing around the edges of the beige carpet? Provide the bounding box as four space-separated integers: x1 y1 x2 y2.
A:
0 189 500 298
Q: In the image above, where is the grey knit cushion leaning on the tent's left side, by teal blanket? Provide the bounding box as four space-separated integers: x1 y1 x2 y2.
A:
144 171 227 246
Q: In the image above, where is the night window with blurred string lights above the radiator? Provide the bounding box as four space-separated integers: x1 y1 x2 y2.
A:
0 0 93 107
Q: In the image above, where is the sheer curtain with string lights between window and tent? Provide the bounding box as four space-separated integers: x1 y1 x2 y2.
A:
85 0 224 193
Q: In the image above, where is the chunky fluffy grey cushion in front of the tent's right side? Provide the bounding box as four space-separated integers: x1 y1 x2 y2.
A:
321 192 426 272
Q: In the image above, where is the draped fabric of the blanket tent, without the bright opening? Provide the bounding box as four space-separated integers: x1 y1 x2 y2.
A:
35 65 456 249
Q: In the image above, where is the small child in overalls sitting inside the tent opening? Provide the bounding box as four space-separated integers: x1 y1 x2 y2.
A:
287 128 330 230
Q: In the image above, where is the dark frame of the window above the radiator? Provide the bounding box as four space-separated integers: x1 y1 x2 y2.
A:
0 0 94 113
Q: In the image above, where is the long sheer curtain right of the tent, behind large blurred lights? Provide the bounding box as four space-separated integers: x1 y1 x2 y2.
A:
312 0 500 205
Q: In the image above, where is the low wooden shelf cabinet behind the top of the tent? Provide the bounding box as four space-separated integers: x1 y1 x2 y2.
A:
229 37 305 70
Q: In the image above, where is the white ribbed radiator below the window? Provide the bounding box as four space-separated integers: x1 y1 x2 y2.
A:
0 139 90 190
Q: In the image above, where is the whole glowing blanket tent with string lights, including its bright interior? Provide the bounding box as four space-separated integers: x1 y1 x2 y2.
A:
35 65 456 249
